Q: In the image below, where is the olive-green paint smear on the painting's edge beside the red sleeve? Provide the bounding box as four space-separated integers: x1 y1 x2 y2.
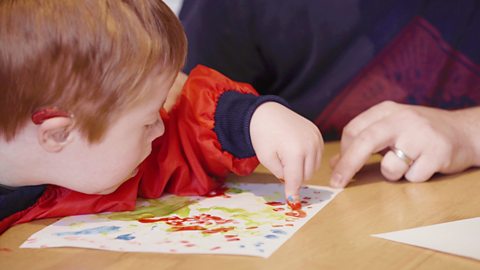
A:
105 195 196 221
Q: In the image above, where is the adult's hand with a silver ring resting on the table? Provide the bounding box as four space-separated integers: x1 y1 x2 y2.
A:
330 101 480 187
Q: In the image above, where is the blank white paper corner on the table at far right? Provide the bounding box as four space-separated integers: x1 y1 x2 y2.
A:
372 217 480 260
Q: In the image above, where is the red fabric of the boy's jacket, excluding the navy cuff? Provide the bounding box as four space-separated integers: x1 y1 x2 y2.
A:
0 66 258 233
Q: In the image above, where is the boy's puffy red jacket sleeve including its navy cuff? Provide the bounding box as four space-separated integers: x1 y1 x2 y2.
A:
140 66 282 198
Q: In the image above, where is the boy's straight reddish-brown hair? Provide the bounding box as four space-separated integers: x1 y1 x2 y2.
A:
0 0 187 142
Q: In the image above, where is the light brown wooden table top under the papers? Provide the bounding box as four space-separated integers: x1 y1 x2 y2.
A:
0 143 480 270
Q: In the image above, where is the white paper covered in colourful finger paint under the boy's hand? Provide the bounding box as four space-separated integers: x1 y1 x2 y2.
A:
21 183 340 257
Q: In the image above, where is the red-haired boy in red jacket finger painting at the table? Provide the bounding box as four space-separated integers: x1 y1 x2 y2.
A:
0 0 323 232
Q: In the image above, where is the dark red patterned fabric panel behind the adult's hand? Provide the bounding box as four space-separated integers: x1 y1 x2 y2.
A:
315 17 480 134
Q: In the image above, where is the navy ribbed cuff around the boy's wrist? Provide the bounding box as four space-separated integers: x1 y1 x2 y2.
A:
214 90 288 158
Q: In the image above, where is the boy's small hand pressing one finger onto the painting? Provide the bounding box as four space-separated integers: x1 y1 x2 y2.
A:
250 102 323 205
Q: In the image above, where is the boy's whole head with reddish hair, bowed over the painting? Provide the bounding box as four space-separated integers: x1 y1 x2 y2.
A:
0 0 186 193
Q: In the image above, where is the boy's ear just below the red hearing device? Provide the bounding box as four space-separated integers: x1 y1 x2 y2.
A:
38 116 74 152
